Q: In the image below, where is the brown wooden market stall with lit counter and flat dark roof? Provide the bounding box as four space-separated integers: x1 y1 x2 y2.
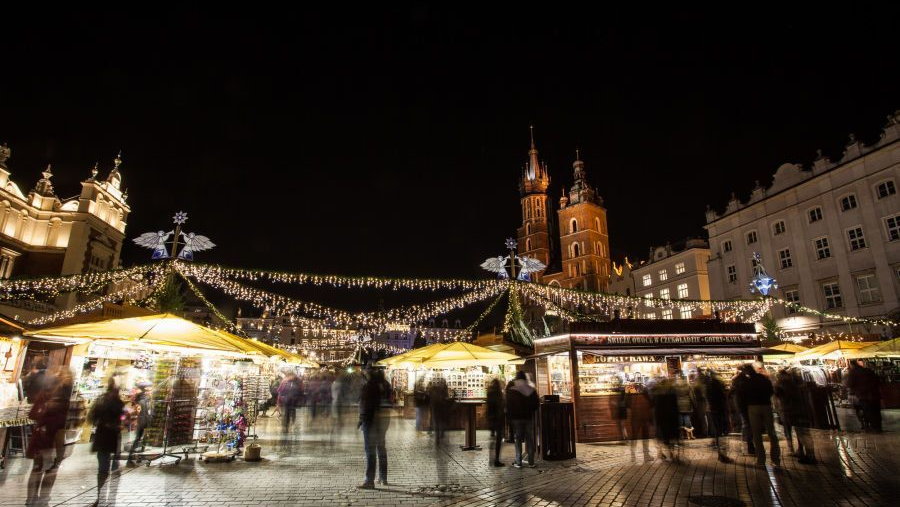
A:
531 319 773 442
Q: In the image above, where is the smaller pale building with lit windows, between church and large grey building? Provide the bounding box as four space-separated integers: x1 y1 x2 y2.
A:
631 239 712 319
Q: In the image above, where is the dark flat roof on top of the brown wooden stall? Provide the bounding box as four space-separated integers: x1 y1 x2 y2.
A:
569 319 756 335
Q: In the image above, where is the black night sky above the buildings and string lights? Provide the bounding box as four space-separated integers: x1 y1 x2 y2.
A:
0 3 900 277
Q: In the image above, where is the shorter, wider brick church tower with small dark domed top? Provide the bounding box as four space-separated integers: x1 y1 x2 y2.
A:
557 151 610 292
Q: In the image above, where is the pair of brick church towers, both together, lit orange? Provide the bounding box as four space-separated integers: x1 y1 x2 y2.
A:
518 129 610 291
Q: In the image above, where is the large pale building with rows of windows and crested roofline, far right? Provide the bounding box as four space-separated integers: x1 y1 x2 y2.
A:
705 111 900 335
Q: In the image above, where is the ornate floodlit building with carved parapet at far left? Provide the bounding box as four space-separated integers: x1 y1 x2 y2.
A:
0 145 131 318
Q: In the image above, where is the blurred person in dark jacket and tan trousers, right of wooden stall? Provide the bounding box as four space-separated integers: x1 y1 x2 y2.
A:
739 363 781 466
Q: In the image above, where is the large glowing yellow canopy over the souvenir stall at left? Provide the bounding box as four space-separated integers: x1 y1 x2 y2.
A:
25 313 257 354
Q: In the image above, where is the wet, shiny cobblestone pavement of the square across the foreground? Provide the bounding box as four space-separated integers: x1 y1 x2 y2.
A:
0 411 900 507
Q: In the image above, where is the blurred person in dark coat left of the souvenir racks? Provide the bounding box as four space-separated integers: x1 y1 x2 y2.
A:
89 379 125 505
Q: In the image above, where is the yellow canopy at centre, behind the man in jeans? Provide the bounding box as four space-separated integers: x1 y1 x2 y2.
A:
379 342 519 369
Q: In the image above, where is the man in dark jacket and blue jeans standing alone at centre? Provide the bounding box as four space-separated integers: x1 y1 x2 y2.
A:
358 369 393 489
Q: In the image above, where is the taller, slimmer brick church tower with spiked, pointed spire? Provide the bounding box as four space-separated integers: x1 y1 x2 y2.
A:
518 126 550 282
